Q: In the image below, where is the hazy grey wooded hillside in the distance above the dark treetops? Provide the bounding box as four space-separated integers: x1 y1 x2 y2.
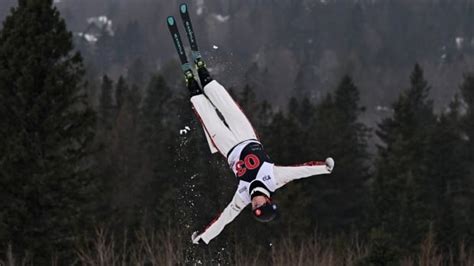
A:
0 0 474 124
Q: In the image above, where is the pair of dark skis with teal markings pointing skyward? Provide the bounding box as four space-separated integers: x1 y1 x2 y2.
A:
167 4 204 79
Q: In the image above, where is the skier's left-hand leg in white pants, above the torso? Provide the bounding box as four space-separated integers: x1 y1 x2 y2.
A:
191 94 240 156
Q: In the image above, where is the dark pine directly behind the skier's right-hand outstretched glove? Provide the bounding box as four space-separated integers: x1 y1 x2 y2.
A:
306 76 369 232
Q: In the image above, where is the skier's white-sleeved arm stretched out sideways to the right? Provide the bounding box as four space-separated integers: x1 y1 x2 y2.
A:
273 158 334 188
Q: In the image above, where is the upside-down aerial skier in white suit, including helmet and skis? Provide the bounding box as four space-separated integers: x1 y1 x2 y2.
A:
167 4 334 244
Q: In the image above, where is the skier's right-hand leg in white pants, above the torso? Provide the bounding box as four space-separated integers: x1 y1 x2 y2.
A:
200 74 258 142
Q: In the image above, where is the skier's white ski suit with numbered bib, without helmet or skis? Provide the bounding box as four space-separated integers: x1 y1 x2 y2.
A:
191 80 334 244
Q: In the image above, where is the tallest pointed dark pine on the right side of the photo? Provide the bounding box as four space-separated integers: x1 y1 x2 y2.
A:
373 64 435 258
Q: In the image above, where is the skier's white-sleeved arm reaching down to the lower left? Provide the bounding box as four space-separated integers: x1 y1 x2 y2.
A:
191 192 247 244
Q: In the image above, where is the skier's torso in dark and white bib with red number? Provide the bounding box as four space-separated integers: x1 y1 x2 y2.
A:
227 140 276 203
